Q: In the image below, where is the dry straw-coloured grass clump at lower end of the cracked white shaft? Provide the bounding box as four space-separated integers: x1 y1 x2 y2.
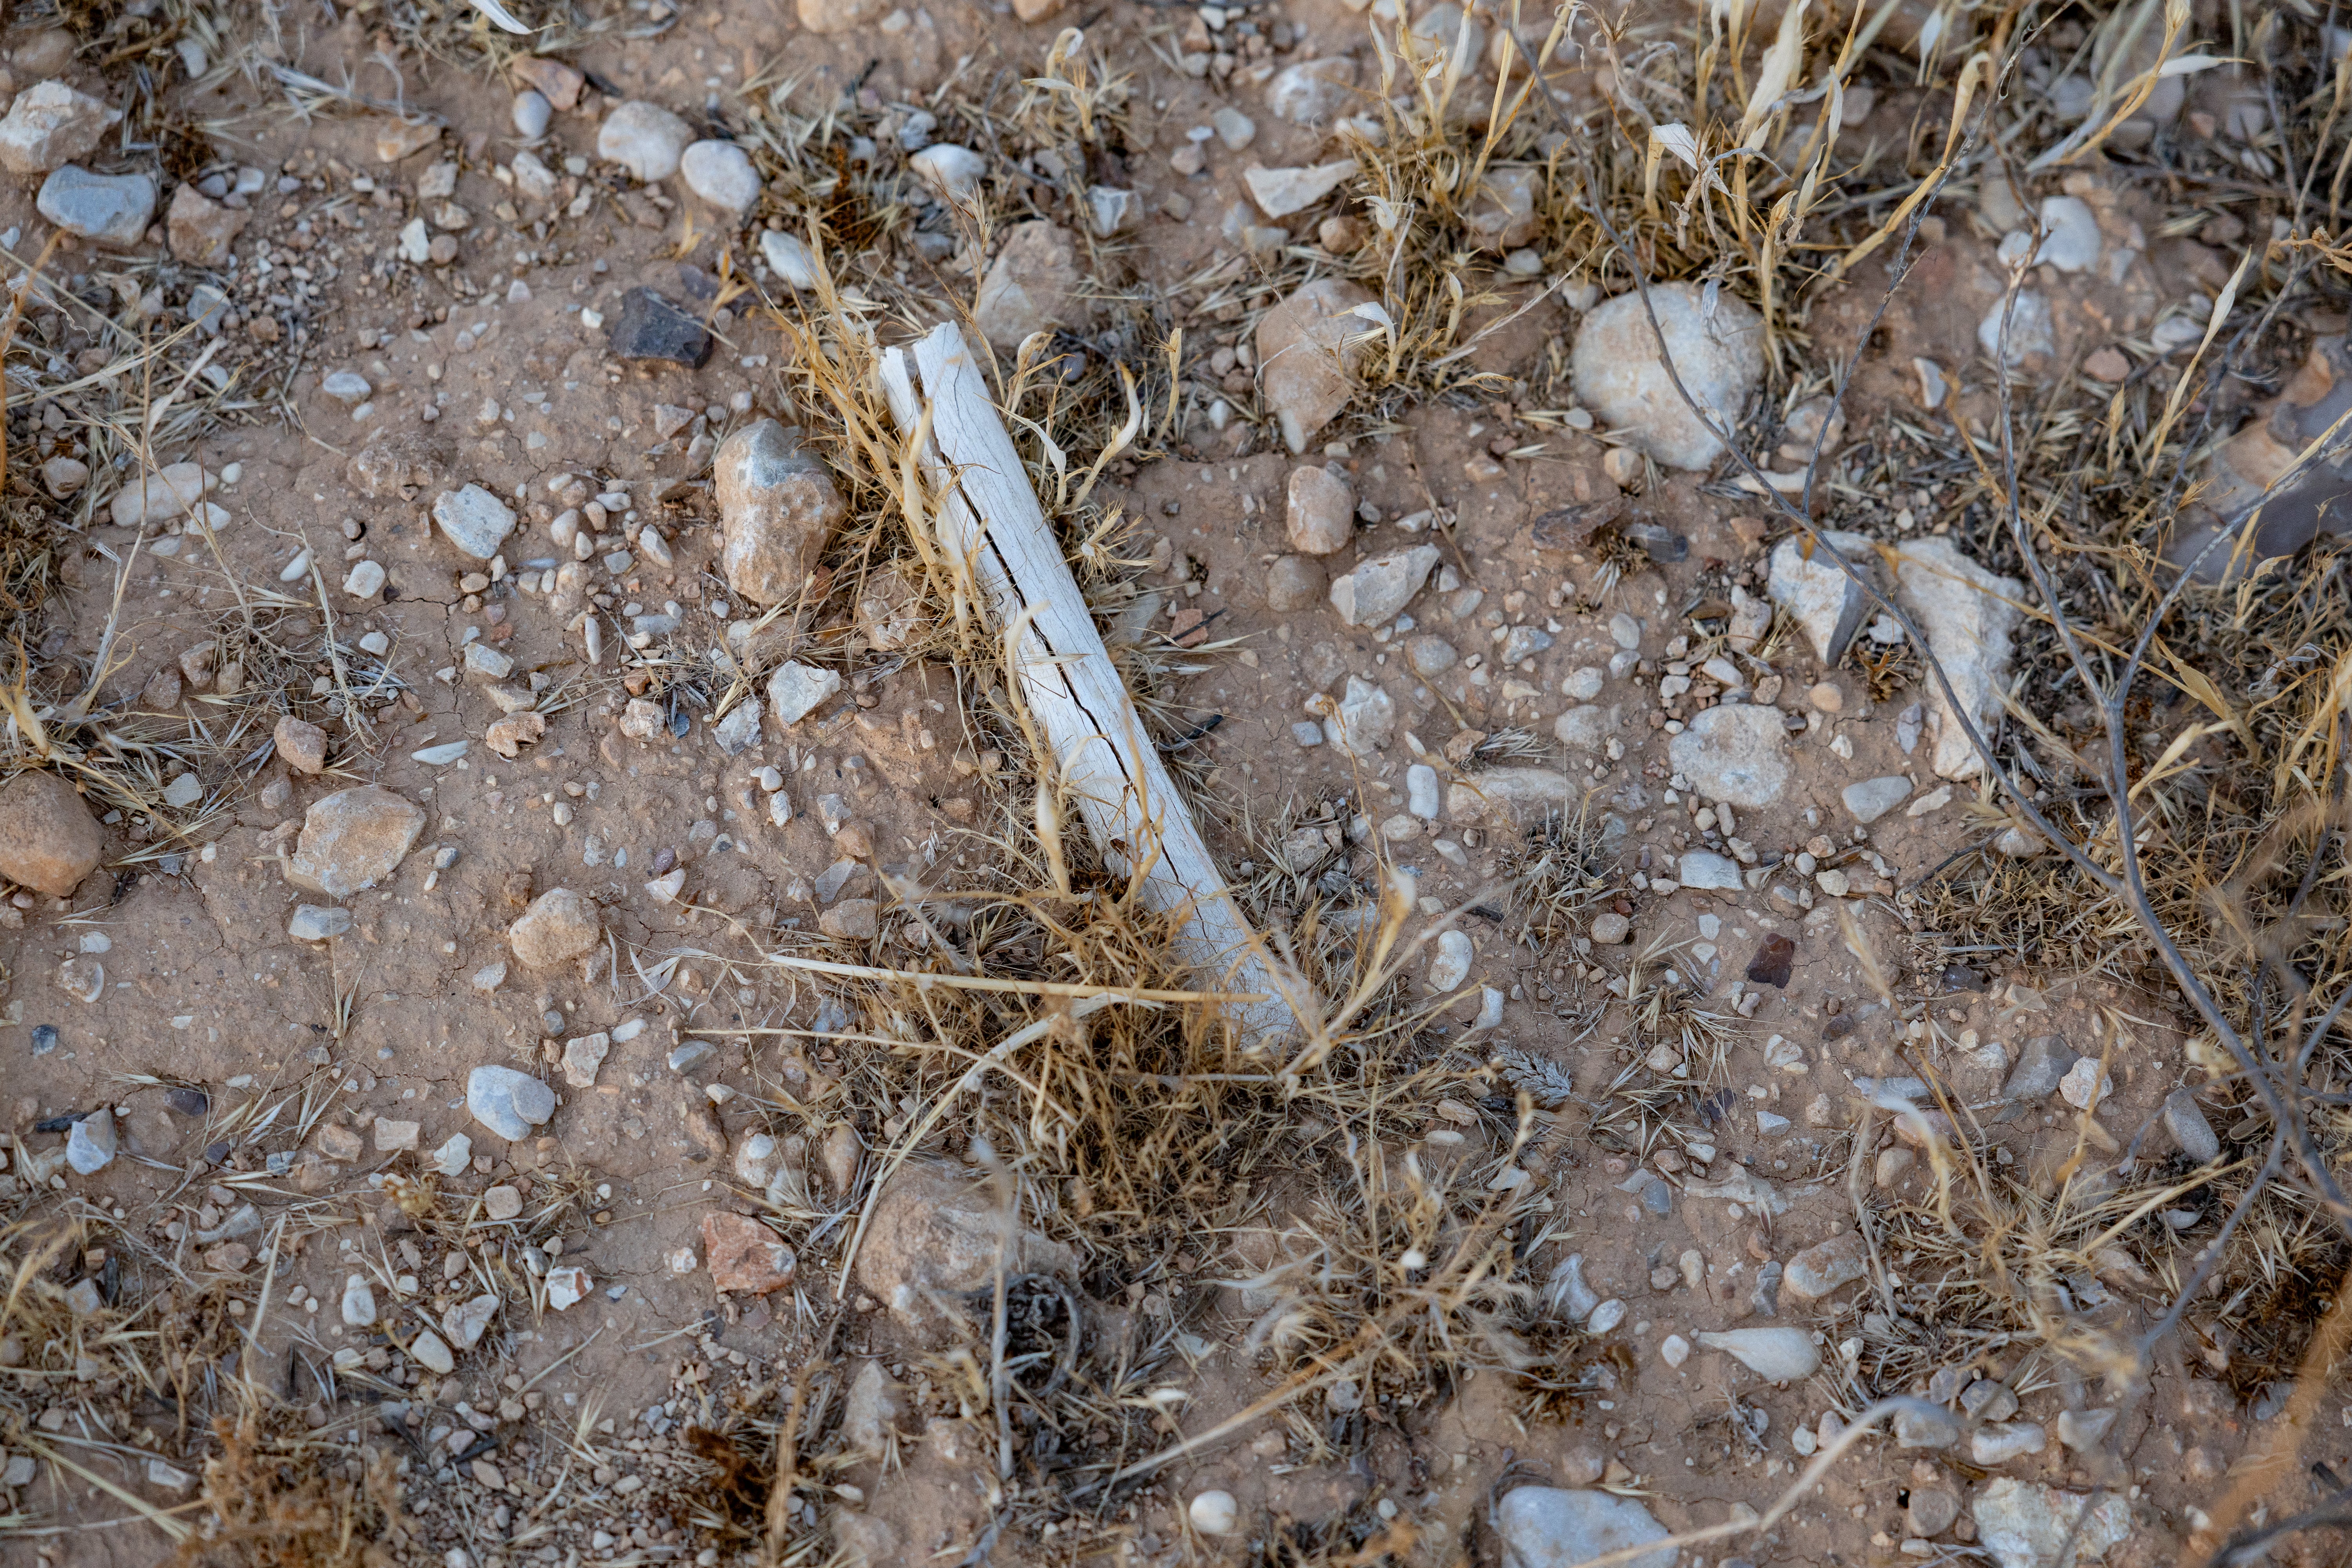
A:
715 820 1590 1561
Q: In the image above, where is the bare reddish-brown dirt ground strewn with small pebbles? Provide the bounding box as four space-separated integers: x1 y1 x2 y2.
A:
0 0 2343 1566
